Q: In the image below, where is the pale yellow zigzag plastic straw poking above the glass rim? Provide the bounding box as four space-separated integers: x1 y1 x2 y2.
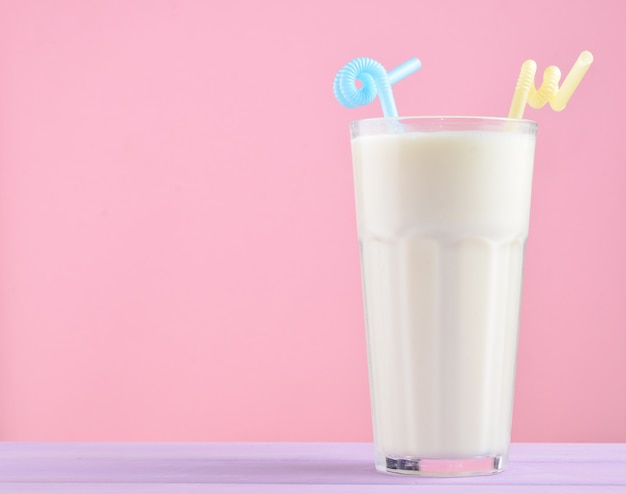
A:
509 51 593 118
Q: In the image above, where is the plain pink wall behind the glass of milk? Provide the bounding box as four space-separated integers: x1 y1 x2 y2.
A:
0 0 626 442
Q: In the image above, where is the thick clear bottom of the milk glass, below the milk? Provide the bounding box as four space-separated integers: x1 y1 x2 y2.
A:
376 456 507 477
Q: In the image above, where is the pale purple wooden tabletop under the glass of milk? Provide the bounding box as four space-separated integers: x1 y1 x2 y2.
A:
0 443 626 494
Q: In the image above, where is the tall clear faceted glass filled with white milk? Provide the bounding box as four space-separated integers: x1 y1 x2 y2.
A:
352 117 537 476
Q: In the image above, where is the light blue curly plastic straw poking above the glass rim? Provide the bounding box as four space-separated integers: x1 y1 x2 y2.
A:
334 57 422 117
